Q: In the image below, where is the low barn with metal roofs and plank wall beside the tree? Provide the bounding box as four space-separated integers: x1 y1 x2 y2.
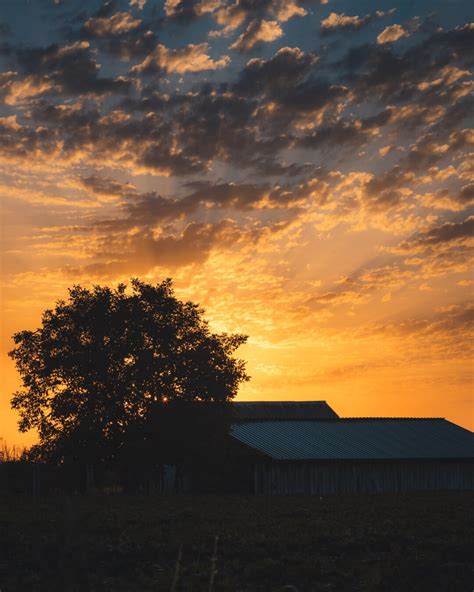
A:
228 401 474 495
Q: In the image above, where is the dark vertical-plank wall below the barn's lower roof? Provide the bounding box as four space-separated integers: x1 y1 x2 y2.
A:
254 460 474 495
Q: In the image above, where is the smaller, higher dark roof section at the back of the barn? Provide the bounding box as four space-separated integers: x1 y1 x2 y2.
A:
232 401 339 421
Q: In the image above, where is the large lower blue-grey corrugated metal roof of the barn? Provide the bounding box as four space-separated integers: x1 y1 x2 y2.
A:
231 418 474 460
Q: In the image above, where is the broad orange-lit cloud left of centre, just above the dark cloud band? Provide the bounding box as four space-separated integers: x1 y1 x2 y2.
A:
131 43 230 74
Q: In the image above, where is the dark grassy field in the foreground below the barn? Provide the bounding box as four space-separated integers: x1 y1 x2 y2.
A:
0 493 474 592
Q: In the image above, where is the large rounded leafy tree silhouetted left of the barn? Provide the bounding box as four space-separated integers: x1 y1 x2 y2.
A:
9 279 248 480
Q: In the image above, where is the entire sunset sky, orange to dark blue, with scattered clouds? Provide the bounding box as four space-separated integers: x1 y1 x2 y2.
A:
0 0 474 445
